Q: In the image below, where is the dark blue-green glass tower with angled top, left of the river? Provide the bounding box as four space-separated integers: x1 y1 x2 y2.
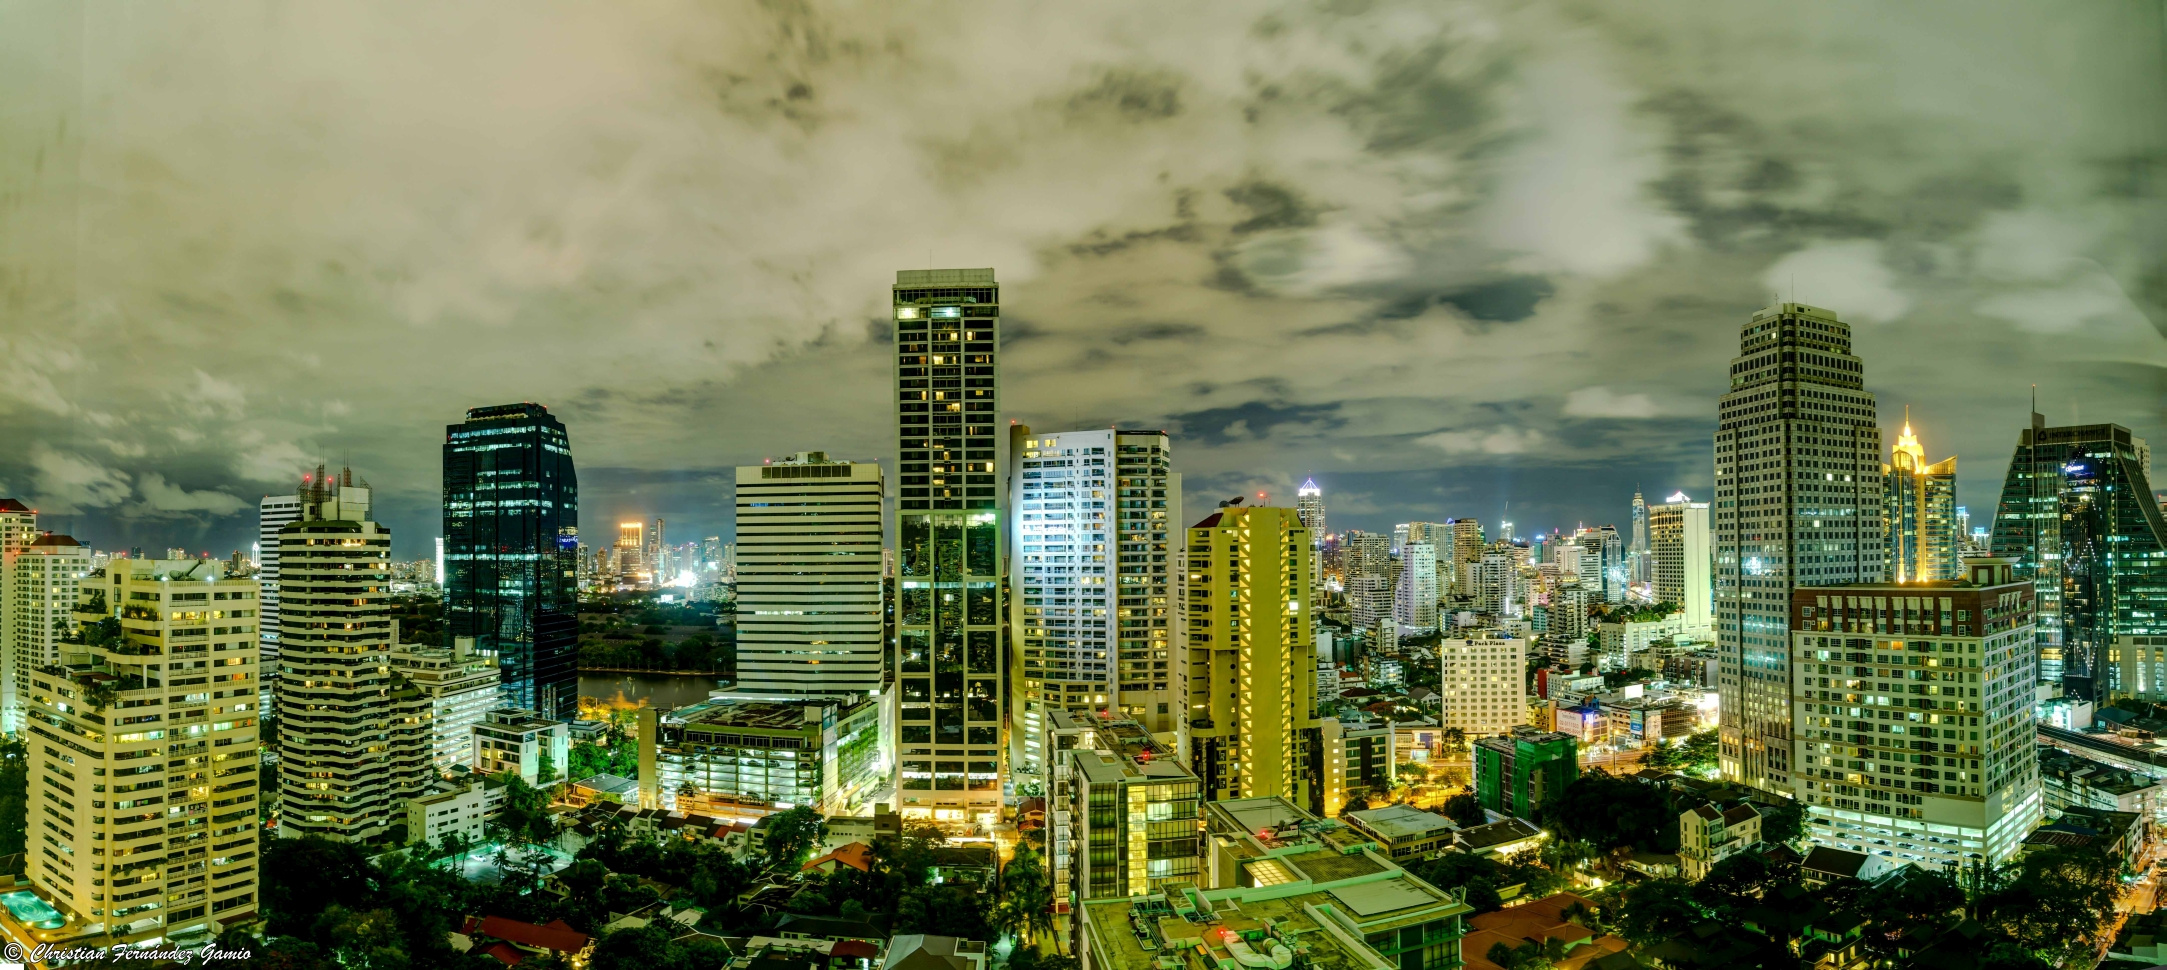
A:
444 405 579 721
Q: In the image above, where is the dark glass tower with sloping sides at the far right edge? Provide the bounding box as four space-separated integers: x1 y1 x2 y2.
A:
1991 411 2167 702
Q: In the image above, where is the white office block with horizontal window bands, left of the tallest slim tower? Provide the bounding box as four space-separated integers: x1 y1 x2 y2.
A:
736 450 884 697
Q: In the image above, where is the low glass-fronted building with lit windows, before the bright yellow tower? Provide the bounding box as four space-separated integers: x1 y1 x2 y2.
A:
1053 719 1201 901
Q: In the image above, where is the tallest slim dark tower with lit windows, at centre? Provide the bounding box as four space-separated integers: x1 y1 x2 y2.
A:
891 268 1008 827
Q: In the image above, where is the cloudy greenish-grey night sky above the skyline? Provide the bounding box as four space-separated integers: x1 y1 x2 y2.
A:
0 0 2167 556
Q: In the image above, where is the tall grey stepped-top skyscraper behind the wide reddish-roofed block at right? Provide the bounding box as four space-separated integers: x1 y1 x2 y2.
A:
1714 303 1883 792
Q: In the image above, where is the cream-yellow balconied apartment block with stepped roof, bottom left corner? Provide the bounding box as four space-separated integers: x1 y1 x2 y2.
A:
24 559 262 944
